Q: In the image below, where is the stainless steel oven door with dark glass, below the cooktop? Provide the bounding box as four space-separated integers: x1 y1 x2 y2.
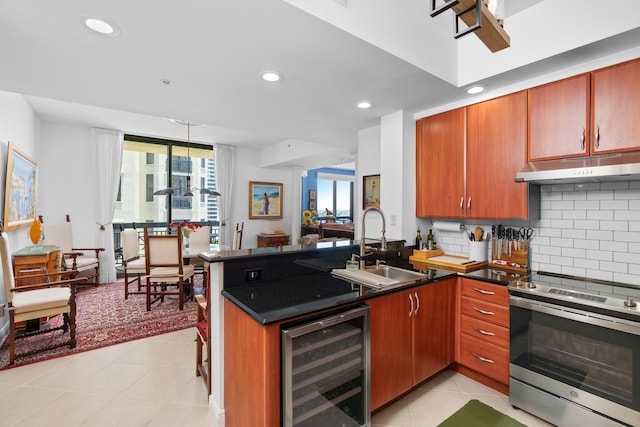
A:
510 296 640 422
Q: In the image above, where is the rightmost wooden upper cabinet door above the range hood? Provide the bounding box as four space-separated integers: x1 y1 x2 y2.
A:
591 59 640 153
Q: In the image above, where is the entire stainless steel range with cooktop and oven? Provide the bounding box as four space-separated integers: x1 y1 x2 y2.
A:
508 273 640 427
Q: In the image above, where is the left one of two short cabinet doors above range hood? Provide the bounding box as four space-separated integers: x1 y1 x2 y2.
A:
528 74 591 161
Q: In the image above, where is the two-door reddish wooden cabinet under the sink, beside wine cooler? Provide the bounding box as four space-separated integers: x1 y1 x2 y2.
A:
367 279 455 410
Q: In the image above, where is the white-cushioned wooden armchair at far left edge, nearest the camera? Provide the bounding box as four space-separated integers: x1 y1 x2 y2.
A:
0 223 86 365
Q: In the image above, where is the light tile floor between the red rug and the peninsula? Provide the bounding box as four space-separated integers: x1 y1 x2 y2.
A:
0 329 216 427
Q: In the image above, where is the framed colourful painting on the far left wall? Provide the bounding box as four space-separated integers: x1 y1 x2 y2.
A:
4 144 38 231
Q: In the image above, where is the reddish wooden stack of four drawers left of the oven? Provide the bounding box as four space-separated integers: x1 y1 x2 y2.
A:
456 278 509 393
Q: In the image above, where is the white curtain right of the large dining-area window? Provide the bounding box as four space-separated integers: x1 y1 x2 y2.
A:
214 144 236 248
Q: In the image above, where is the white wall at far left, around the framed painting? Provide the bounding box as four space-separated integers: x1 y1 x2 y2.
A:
0 91 42 342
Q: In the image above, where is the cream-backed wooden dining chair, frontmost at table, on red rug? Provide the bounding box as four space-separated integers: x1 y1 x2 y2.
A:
144 227 194 311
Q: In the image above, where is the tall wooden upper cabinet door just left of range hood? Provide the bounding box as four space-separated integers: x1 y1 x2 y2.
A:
465 91 529 219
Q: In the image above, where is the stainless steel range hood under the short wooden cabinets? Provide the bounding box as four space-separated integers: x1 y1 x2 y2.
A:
516 151 640 184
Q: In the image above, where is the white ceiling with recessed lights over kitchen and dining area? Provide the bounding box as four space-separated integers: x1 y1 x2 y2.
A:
0 0 640 171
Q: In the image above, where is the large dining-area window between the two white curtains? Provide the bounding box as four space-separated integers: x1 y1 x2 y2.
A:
114 135 218 227
